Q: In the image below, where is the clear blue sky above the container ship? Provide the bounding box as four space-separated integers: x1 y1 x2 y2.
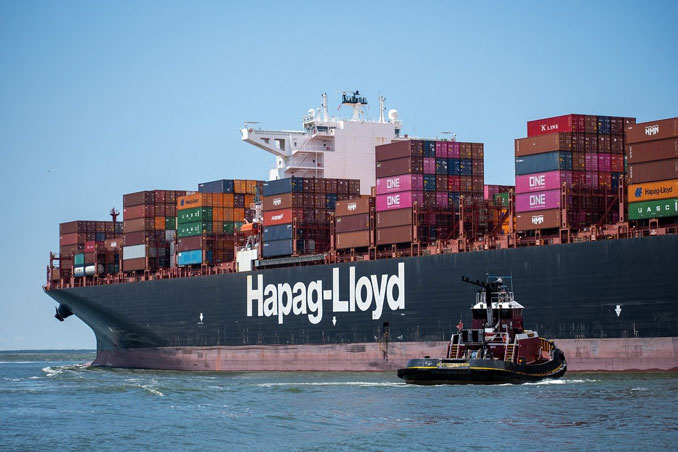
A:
0 1 678 350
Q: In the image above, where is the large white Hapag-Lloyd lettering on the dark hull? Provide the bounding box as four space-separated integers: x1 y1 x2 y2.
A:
247 262 405 325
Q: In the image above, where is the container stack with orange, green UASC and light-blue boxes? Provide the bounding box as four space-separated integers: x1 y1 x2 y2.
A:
176 179 263 266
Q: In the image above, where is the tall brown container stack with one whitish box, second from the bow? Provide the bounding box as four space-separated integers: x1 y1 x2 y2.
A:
122 190 186 272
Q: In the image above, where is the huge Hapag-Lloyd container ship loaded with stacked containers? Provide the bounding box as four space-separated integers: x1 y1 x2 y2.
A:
44 92 678 371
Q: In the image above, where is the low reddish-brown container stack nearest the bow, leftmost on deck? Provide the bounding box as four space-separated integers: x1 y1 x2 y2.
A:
59 220 122 279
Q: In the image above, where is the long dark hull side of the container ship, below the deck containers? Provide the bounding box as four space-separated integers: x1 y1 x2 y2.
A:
47 235 678 370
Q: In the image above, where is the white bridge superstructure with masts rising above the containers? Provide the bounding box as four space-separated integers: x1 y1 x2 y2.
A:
240 91 401 194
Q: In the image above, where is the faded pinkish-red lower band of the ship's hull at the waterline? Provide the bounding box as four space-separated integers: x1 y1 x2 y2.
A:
92 337 678 372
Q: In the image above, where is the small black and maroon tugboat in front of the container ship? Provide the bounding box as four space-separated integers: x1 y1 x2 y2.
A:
398 276 567 385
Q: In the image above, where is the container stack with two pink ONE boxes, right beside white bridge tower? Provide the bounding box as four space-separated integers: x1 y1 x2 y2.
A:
376 140 485 245
